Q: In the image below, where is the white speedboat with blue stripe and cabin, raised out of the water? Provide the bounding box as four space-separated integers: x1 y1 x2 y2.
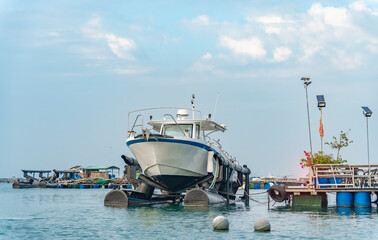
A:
126 95 244 192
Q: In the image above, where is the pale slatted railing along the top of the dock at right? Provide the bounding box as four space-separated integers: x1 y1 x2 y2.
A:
308 164 378 188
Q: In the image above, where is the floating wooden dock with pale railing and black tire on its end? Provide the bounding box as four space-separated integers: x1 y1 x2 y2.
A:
269 164 378 207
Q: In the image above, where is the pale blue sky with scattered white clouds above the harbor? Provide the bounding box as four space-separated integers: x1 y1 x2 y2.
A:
0 0 378 177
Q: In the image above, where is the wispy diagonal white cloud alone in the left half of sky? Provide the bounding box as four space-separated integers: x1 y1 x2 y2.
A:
83 18 136 60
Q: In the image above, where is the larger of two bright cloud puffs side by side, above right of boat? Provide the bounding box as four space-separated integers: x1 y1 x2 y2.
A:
220 36 266 59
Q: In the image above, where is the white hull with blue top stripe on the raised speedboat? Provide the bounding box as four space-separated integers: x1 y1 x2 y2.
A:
126 138 210 191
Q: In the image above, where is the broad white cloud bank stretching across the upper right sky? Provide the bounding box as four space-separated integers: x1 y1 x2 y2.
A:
187 1 378 71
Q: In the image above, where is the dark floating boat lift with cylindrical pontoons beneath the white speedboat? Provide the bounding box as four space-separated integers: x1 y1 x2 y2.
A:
104 154 251 207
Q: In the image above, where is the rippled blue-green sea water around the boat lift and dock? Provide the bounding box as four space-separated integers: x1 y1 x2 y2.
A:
0 184 378 240
